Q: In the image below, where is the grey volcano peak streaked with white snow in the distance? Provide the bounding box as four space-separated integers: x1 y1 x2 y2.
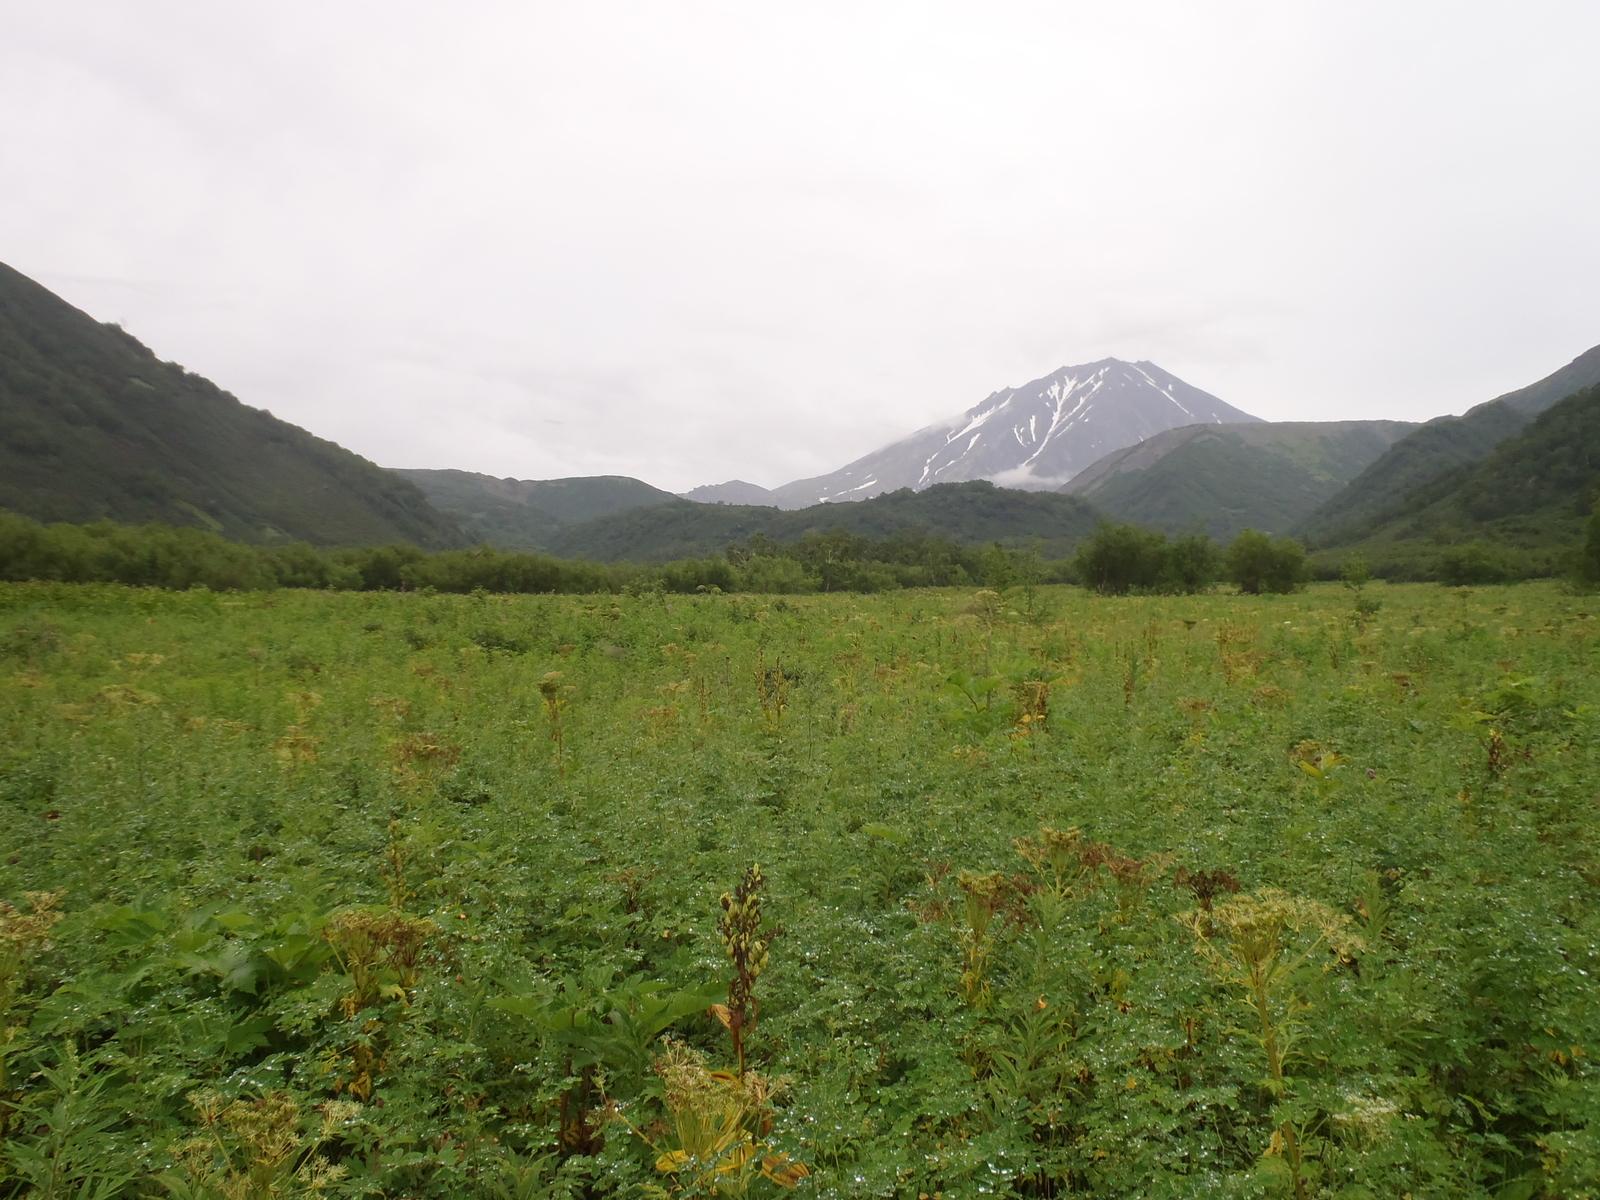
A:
773 358 1259 509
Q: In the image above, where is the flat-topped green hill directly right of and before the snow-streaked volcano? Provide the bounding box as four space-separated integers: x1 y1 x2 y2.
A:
1061 421 1416 541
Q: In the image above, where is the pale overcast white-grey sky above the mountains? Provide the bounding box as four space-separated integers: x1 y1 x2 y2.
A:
0 0 1600 490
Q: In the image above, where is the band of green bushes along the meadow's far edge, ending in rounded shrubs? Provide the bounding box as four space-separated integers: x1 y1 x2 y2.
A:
0 512 1310 595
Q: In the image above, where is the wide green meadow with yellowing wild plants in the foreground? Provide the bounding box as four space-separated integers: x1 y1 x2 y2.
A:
0 582 1600 1200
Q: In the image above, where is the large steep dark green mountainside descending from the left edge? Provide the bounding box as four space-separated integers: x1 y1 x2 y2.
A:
0 264 469 549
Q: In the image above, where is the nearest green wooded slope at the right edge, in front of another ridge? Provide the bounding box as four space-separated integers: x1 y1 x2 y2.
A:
1320 386 1600 576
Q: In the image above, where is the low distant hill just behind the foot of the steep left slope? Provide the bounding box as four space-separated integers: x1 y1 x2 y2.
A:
395 469 678 550
